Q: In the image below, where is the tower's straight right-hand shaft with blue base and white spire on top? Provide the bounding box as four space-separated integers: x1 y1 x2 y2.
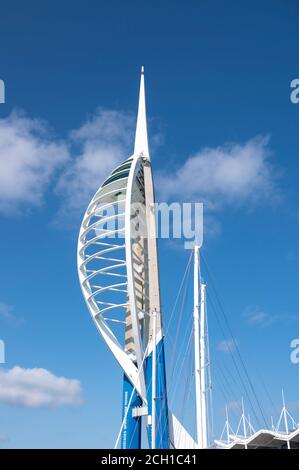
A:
134 66 169 449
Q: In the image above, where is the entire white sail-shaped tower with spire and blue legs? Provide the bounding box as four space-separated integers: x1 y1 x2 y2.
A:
78 67 169 448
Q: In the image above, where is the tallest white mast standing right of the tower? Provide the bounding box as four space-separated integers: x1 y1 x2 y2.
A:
193 246 203 449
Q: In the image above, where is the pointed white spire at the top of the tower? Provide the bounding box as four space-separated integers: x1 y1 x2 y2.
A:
134 66 150 158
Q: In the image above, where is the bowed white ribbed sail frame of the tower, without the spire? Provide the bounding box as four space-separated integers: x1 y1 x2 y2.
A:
77 158 146 403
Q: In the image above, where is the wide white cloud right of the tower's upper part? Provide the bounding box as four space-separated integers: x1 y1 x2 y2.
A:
158 137 277 209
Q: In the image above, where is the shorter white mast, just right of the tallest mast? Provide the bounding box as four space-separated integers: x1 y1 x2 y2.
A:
200 282 208 449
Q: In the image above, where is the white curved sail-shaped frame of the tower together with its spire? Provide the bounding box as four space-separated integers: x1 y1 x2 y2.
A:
77 68 155 404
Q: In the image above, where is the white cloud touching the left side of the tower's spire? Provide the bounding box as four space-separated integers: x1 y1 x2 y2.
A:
56 109 133 224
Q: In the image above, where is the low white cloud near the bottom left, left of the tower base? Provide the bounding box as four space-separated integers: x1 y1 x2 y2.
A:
0 366 82 408
